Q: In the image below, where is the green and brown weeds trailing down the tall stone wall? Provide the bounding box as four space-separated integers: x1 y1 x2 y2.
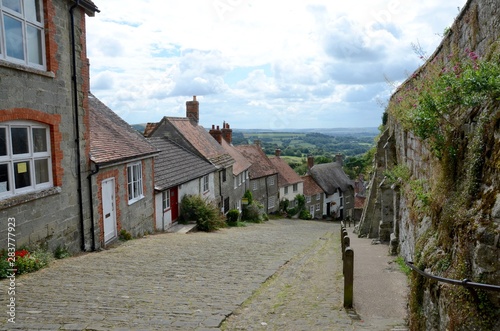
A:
386 50 500 330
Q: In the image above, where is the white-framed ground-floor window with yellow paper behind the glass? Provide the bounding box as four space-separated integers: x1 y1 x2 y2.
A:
0 122 53 198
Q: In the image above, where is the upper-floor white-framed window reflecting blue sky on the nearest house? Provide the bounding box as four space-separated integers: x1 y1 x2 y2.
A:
0 0 45 70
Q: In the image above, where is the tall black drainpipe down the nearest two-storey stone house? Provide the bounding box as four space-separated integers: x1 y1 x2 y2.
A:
69 0 86 252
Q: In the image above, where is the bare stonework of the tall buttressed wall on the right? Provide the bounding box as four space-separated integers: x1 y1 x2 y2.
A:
359 0 500 330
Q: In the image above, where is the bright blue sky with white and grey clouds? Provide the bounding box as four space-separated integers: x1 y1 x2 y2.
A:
87 0 466 129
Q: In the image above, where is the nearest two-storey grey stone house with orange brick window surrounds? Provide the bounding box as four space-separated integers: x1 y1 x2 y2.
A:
0 0 98 252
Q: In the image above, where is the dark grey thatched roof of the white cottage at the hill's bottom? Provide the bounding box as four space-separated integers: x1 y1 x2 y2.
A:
309 162 354 195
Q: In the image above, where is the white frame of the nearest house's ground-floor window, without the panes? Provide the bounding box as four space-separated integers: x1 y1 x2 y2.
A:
0 121 54 199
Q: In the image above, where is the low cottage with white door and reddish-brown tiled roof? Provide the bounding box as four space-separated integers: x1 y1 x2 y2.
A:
88 94 157 247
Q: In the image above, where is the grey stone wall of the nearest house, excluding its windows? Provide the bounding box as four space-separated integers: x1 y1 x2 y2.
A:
0 0 90 252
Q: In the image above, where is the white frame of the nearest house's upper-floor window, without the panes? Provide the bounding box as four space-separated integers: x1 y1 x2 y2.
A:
0 0 47 70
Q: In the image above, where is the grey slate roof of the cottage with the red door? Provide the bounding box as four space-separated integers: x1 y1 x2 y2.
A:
148 137 217 191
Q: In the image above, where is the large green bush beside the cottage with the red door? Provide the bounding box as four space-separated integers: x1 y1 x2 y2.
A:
180 195 226 232
